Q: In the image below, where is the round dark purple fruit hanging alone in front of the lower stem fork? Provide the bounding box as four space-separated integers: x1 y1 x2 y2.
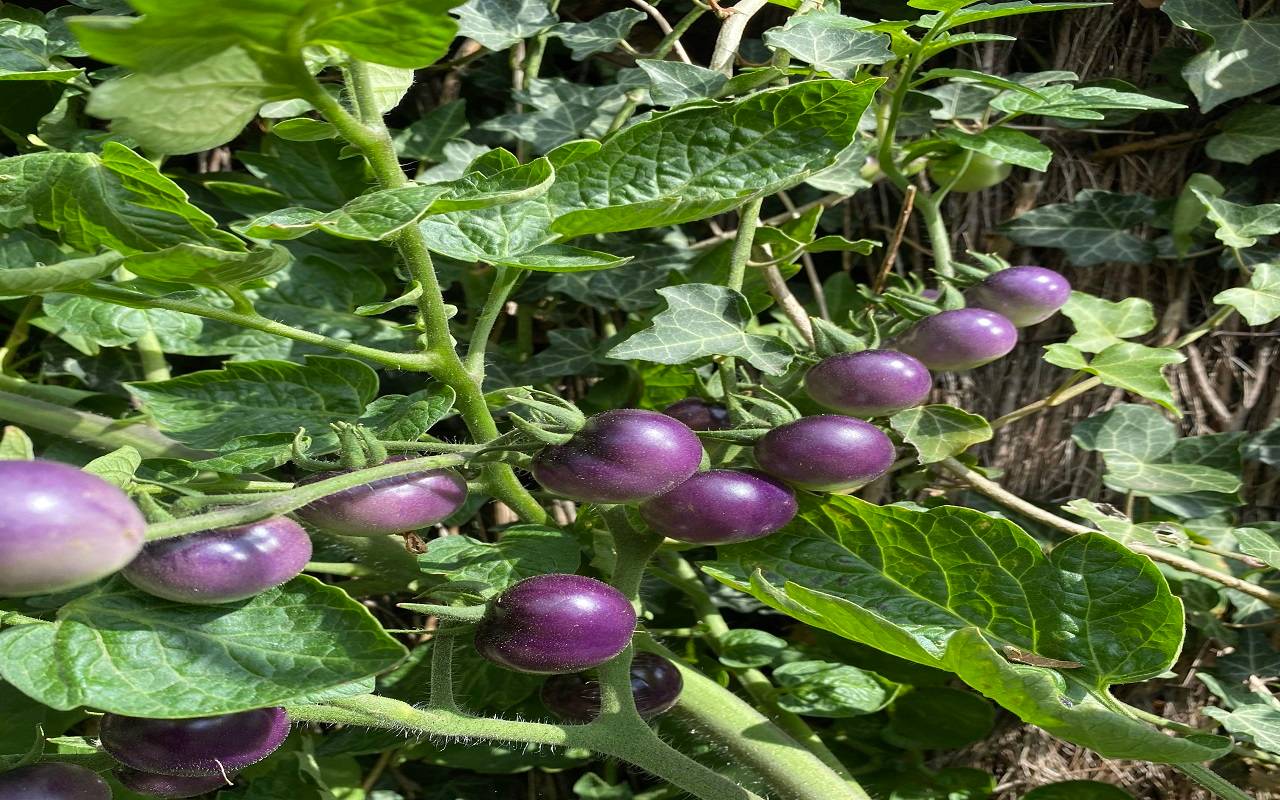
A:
476 573 636 673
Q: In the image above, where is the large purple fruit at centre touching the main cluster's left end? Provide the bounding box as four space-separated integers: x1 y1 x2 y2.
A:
532 408 703 503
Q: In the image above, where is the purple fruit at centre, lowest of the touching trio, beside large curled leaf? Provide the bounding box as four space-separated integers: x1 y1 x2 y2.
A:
640 470 796 544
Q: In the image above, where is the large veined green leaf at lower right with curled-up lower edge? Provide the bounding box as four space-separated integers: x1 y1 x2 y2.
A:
707 497 1229 762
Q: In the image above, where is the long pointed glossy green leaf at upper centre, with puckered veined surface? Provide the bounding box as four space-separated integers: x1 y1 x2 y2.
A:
548 79 881 237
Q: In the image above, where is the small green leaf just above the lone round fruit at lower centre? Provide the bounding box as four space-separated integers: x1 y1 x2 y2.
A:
417 525 579 598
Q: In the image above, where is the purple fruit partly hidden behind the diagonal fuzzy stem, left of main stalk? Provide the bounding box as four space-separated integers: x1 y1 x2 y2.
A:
297 456 467 536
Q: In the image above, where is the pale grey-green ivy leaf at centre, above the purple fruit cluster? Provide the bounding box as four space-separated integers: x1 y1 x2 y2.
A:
608 283 795 375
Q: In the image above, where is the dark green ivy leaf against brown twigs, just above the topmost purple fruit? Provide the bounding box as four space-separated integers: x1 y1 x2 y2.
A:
1000 189 1156 266
